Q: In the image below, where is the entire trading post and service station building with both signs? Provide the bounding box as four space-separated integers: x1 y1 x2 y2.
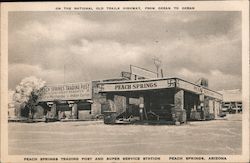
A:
21 78 222 123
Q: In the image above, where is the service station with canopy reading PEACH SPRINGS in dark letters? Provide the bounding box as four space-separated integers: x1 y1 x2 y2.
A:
98 78 222 123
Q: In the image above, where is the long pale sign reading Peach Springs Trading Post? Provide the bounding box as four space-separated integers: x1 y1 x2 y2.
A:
39 82 92 101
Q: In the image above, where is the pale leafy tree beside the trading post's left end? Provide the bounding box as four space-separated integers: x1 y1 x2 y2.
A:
14 76 45 118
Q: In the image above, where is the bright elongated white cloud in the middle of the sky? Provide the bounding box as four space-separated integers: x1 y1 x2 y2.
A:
70 39 144 67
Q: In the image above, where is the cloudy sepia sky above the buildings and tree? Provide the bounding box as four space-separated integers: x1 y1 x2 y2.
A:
8 11 242 90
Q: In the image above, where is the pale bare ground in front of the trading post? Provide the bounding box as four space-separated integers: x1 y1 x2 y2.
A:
9 115 242 155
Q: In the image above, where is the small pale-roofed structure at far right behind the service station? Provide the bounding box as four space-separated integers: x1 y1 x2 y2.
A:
218 89 242 113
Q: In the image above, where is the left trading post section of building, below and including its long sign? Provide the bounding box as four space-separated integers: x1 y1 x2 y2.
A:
36 78 128 120
